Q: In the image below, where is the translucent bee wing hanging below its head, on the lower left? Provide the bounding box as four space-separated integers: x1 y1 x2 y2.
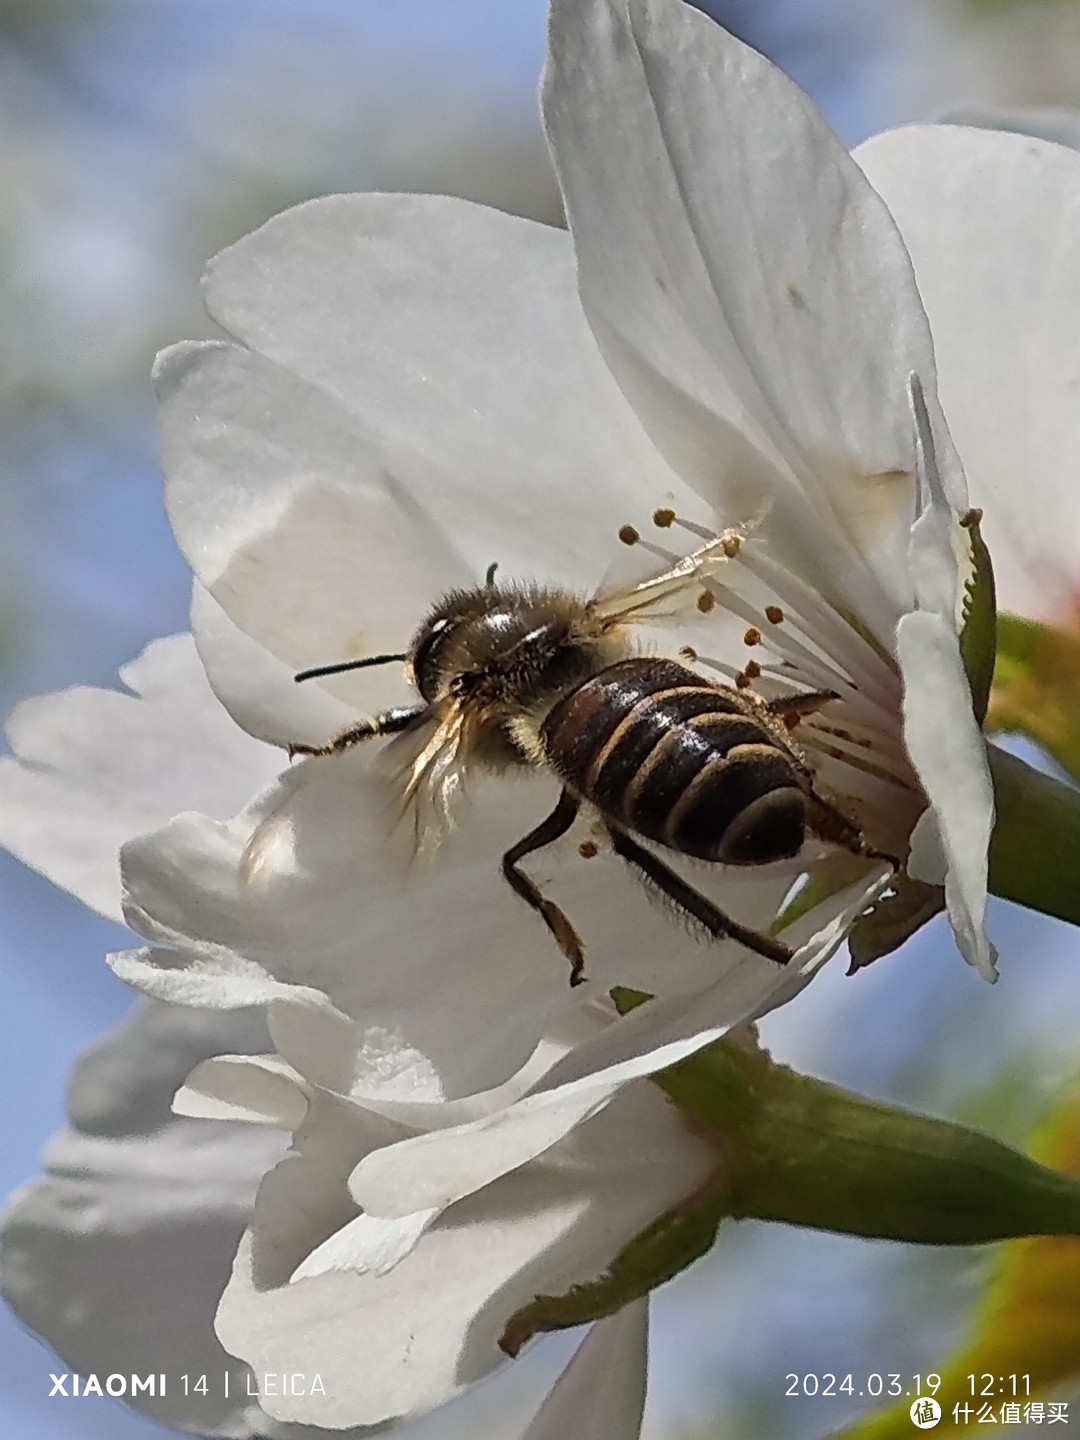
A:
379 698 474 854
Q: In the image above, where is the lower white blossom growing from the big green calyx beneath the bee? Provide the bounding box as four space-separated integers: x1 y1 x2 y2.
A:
174 1002 711 1434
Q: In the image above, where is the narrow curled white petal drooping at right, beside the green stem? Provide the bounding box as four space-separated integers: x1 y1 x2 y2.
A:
896 611 996 981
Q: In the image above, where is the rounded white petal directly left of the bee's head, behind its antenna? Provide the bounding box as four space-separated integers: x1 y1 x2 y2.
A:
156 344 466 720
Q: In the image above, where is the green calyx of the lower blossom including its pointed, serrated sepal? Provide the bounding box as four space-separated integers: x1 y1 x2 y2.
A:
500 1019 1080 1354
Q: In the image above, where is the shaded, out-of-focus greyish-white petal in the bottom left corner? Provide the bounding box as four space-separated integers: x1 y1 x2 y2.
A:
3 1005 285 1437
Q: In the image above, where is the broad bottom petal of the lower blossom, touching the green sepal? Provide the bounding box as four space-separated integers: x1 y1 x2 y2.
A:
217 1086 711 1427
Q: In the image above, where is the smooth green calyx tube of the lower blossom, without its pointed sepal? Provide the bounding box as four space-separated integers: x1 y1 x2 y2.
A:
657 1040 1080 1244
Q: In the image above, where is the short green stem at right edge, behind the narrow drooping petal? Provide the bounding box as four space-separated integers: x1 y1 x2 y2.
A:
986 744 1080 924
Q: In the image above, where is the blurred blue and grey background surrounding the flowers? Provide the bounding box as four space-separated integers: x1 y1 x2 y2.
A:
0 0 1080 1440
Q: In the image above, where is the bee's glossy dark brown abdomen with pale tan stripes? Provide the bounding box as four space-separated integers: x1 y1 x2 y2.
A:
540 658 806 865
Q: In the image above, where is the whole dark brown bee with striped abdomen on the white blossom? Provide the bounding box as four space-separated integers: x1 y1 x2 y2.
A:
289 533 876 985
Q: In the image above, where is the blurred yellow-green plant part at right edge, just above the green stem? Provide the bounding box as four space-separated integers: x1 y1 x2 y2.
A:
986 615 1080 780
